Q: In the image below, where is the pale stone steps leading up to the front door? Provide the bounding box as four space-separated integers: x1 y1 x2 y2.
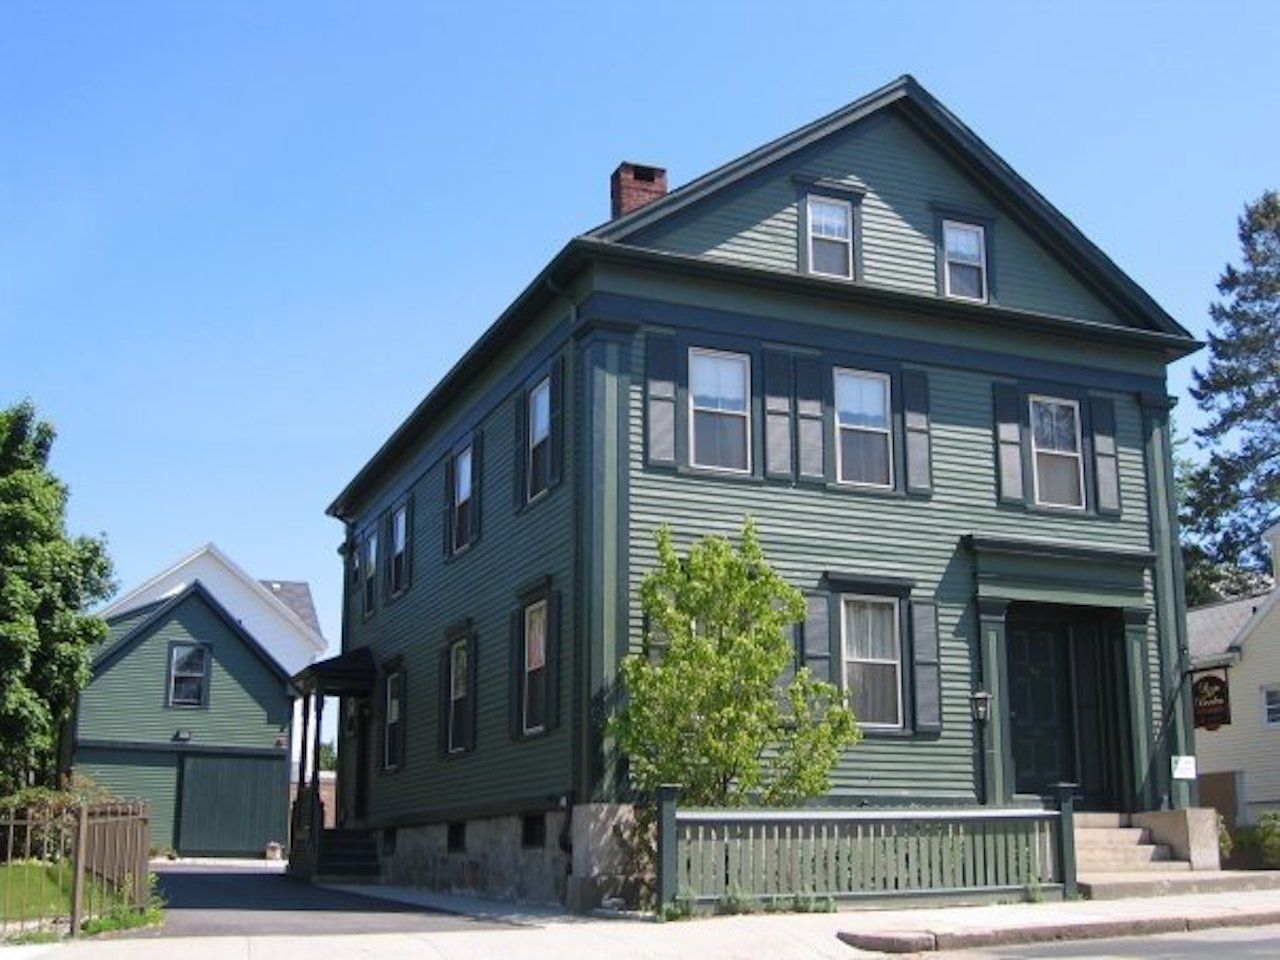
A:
1075 813 1280 900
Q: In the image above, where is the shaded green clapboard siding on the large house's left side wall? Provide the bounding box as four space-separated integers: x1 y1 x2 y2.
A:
340 299 575 824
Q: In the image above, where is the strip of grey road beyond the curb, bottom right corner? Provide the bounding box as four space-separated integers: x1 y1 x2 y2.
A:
933 927 1280 960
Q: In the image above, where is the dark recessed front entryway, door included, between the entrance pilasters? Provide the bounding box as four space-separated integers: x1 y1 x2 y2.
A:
1007 604 1129 810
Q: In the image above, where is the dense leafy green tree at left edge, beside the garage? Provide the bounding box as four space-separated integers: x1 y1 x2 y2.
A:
0 402 113 795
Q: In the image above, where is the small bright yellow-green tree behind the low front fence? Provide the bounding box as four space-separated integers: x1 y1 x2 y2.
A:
611 518 860 806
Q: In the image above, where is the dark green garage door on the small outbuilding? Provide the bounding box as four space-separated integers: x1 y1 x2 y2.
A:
177 754 289 856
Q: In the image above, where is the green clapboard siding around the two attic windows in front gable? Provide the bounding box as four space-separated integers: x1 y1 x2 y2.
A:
637 114 1119 323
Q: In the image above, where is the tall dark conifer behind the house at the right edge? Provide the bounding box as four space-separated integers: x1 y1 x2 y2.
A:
1181 191 1280 583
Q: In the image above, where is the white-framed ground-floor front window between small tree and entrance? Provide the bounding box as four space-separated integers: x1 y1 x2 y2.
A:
841 596 902 728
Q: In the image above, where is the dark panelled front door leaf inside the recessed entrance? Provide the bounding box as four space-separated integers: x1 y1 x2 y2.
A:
1009 618 1075 796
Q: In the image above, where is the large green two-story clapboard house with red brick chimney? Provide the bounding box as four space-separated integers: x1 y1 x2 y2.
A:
298 77 1198 905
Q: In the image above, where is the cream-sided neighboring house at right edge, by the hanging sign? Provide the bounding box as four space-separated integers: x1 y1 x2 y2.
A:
1187 524 1280 824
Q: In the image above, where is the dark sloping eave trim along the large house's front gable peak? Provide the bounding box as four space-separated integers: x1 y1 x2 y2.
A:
586 77 1190 339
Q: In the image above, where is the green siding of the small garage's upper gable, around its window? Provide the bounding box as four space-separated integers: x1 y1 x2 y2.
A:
77 594 292 748
